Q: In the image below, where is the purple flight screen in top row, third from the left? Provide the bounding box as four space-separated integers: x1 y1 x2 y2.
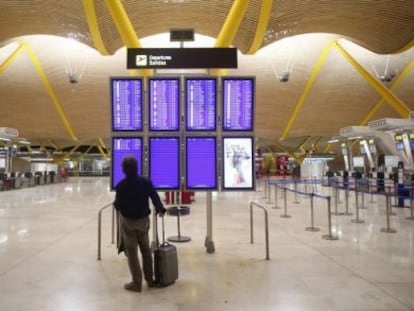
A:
185 78 217 131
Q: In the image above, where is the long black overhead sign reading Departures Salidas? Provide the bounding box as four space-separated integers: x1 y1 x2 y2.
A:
127 48 237 69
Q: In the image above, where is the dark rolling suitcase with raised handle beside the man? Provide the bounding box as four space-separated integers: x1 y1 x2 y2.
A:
154 217 178 287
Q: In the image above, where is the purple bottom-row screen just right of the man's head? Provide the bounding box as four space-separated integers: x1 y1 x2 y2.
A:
149 137 180 190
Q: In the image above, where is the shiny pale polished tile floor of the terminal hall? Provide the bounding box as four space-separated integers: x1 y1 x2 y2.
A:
0 178 414 311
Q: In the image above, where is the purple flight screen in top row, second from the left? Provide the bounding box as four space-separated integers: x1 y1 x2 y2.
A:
149 78 180 131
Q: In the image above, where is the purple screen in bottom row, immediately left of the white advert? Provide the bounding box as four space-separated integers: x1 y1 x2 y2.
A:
186 137 217 190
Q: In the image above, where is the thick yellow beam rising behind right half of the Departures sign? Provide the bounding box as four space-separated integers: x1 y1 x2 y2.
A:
210 0 249 76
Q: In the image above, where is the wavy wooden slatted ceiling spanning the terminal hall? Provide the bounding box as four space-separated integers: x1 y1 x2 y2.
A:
0 0 414 152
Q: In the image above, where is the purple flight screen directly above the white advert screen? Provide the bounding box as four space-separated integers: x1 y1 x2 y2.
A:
222 77 254 131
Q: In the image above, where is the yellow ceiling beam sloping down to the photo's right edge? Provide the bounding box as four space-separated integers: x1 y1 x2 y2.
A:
335 41 410 118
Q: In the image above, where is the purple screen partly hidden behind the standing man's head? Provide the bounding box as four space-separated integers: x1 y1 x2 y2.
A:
111 137 142 189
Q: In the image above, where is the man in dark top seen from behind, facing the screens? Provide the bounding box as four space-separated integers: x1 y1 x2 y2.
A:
114 156 166 292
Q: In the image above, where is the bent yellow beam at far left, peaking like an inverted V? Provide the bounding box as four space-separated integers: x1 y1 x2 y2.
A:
0 41 79 142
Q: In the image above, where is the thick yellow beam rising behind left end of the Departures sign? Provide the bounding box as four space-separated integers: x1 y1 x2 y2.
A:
105 0 153 76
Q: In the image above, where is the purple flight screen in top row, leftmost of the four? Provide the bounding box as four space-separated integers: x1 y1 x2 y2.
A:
111 78 143 131
